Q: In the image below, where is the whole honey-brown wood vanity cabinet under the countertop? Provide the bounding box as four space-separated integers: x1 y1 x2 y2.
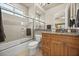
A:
41 33 79 56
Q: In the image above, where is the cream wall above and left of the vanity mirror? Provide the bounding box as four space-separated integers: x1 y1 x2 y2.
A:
45 4 66 28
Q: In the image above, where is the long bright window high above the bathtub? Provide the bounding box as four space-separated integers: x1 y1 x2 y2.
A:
0 3 24 18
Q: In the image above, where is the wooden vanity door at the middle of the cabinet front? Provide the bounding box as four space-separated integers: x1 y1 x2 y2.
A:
51 41 64 56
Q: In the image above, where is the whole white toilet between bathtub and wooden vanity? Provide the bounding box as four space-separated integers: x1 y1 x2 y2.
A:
28 35 41 56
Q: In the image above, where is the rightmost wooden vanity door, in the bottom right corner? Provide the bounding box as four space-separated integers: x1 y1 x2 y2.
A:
66 44 79 56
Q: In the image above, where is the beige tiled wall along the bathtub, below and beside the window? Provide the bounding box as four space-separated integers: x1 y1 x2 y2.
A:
2 4 27 42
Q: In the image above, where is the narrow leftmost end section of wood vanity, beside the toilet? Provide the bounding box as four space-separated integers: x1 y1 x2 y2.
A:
41 34 51 56
